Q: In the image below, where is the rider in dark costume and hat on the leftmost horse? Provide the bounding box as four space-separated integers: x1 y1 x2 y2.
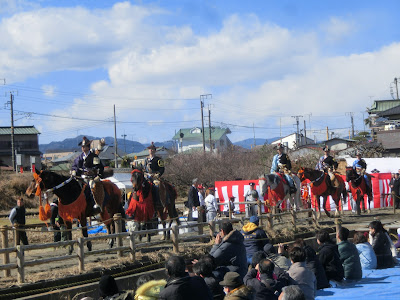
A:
71 136 104 215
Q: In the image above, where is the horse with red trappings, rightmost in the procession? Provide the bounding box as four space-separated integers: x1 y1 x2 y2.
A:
346 167 374 215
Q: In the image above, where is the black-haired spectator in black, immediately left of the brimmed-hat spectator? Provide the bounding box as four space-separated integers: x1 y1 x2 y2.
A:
193 257 225 300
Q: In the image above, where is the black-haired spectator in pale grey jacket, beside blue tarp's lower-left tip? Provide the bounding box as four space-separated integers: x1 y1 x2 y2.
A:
288 247 317 300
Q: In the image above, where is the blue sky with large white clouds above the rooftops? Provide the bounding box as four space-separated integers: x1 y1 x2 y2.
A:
0 0 400 143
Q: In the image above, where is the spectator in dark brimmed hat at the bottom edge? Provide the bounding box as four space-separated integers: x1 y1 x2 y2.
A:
219 272 254 300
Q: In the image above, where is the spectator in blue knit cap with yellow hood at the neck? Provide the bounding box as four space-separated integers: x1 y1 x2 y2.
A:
241 216 269 264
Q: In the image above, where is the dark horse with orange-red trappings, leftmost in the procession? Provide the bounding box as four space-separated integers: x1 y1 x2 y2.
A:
26 170 125 254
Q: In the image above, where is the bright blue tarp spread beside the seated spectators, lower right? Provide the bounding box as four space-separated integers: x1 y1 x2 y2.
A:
315 258 400 300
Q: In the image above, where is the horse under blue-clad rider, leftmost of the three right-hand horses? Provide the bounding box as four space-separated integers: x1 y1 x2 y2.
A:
258 174 301 213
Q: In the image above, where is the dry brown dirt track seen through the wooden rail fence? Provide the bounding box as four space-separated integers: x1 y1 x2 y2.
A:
0 209 400 289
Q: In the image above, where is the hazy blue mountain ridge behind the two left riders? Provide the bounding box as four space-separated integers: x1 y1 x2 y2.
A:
39 135 146 153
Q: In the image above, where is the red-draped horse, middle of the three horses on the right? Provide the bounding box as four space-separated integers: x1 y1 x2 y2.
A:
298 168 347 219
